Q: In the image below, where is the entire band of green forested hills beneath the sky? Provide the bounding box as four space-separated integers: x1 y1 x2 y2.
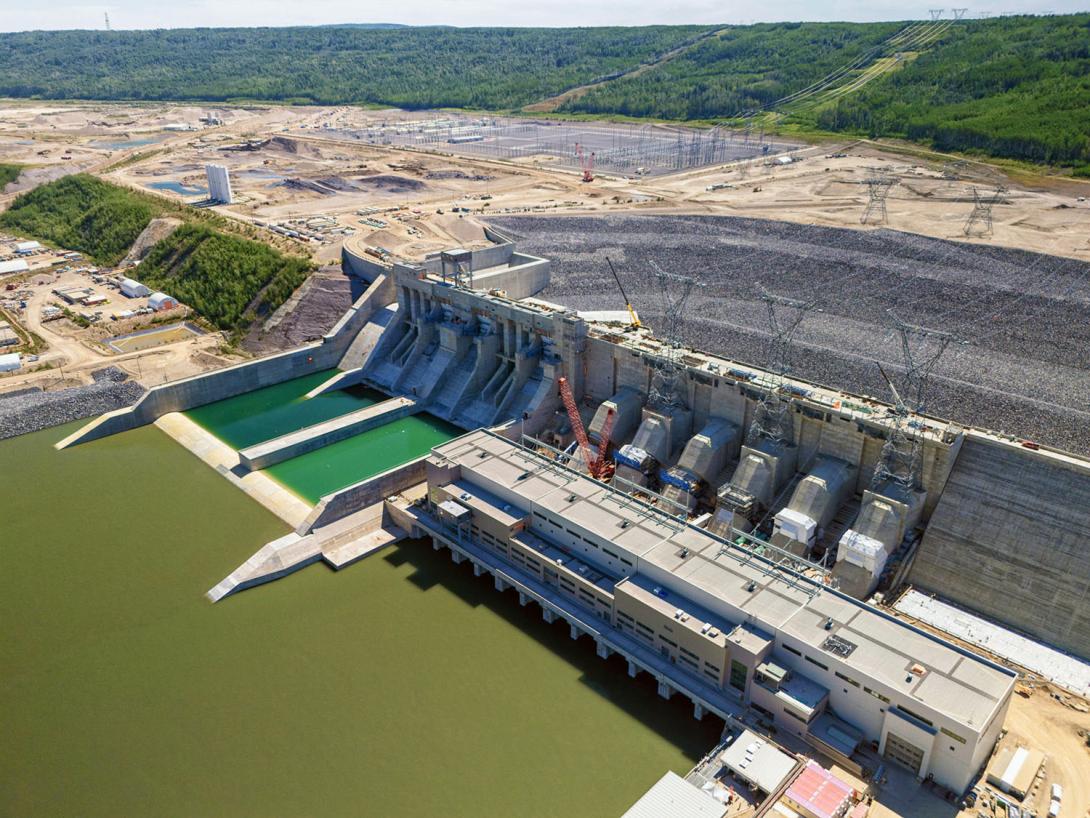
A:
0 14 1090 165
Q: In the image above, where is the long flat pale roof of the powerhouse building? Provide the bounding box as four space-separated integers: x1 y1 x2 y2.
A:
435 431 1015 730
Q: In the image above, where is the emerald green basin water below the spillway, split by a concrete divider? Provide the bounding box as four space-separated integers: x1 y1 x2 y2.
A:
186 370 462 503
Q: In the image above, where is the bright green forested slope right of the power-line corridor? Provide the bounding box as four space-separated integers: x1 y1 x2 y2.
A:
811 14 1090 166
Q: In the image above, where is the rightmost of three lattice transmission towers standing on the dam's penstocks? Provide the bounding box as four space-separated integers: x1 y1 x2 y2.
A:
871 310 956 491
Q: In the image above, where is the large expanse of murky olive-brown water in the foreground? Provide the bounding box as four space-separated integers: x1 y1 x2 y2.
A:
6 424 722 818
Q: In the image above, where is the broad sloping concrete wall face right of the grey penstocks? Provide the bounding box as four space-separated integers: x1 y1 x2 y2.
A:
908 435 1090 658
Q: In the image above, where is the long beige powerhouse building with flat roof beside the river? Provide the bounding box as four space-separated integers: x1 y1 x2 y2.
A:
417 430 1016 791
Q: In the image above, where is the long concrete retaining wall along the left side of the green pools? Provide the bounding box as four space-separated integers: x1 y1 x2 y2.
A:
57 272 393 448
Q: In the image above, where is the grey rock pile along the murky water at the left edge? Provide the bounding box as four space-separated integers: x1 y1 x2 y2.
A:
0 366 145 440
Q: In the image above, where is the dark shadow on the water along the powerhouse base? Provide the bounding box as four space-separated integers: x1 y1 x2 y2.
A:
383 540 723 761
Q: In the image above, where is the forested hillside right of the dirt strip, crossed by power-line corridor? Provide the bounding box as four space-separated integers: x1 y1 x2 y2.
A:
565 14 1090 166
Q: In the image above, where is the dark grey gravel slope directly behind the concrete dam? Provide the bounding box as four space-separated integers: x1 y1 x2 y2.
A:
495 216 1090 454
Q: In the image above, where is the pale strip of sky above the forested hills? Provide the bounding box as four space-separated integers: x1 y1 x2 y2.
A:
0 0 1090 32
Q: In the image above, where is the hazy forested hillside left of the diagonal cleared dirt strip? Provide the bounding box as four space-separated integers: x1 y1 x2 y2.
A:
0 26 707 108
